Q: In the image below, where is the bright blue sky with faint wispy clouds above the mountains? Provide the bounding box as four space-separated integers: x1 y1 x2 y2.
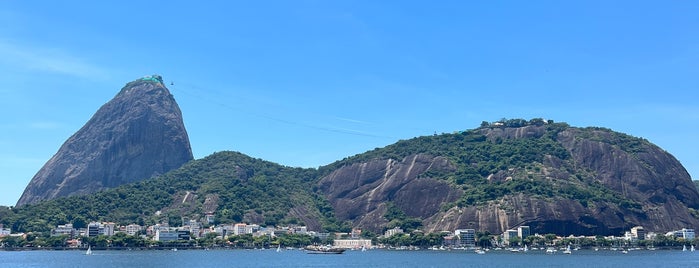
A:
0 0 699 205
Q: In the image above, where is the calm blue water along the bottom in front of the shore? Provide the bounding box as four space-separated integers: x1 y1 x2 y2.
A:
0 250 699 268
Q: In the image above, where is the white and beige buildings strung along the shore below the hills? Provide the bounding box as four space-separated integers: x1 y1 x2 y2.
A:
0 221 695 249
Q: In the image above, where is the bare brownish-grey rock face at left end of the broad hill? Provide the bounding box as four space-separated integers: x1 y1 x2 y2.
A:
319 154 461 230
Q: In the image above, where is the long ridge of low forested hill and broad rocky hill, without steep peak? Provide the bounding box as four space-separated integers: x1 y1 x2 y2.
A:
5 119 699 235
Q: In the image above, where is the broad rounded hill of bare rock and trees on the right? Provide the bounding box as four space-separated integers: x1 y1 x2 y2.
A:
318 122 699 235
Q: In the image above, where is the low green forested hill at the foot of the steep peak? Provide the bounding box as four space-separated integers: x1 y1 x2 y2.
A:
0 152 341 231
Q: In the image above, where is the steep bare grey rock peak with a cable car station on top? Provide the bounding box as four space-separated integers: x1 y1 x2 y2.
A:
17 75 193 206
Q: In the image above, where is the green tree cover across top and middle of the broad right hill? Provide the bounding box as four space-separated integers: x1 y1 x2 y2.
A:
321 119 636 207
